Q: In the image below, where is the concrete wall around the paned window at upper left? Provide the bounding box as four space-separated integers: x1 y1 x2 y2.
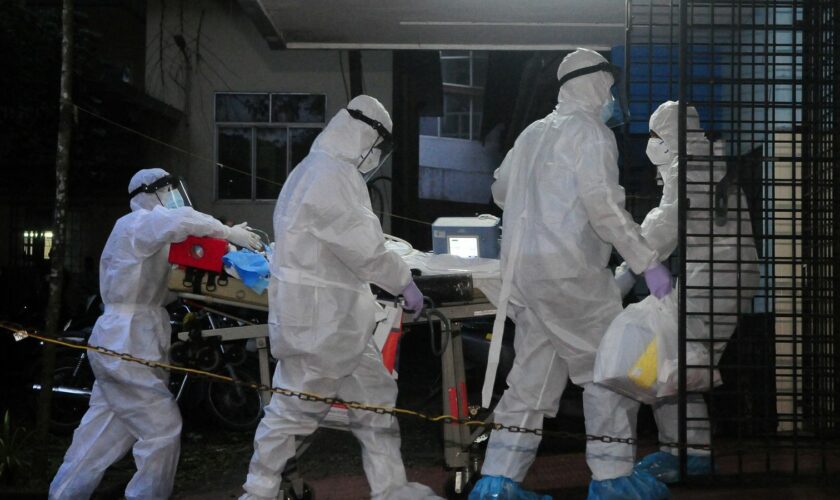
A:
145 0 392 233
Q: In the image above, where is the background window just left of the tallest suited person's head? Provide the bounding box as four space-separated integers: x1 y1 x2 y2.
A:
420 50 487 140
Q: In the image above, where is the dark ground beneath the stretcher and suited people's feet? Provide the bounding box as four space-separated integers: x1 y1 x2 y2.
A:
6 328 840 500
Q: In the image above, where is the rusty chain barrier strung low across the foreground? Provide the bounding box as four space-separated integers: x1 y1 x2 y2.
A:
0 323 711 451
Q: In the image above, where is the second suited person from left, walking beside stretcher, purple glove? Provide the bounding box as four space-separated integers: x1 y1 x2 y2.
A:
241 95 438 500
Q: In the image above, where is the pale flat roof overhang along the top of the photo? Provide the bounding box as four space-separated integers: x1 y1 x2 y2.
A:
239 0 626 50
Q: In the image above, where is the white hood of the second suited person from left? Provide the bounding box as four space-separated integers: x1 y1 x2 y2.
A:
312 95 393 175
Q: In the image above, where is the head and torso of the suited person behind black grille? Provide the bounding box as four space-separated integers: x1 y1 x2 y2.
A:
642 101 759 362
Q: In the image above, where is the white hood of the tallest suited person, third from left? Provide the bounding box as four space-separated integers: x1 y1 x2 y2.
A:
557 49 615 114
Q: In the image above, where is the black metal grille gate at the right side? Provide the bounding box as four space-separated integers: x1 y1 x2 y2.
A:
622 0 840 475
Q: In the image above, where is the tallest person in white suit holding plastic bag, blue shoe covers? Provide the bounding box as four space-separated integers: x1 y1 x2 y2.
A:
470 49 671 500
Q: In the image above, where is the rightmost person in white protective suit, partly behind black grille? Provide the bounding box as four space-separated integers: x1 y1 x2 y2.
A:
615 101 759 483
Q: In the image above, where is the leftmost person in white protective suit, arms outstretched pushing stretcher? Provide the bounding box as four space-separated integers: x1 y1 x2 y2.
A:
49 168 260 499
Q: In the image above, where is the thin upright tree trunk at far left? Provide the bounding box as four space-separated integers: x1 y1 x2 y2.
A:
34 0 74 479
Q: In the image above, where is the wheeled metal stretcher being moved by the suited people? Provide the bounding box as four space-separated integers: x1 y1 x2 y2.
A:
168 239 498 494
